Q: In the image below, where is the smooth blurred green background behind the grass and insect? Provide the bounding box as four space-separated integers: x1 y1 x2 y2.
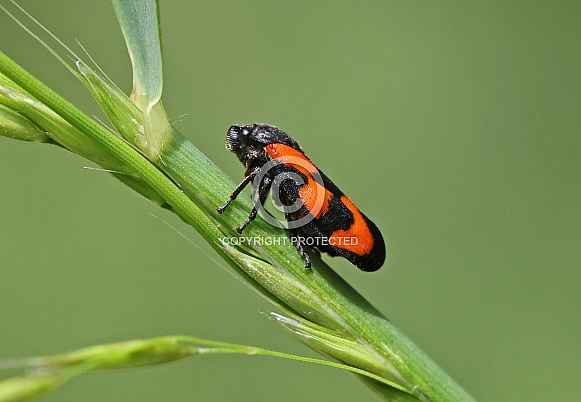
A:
0 0 581 401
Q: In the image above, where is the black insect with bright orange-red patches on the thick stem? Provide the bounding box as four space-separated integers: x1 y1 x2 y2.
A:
218 124 385 271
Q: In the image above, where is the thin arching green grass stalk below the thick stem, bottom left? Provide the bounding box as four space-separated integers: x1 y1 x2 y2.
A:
0 336 415 402
